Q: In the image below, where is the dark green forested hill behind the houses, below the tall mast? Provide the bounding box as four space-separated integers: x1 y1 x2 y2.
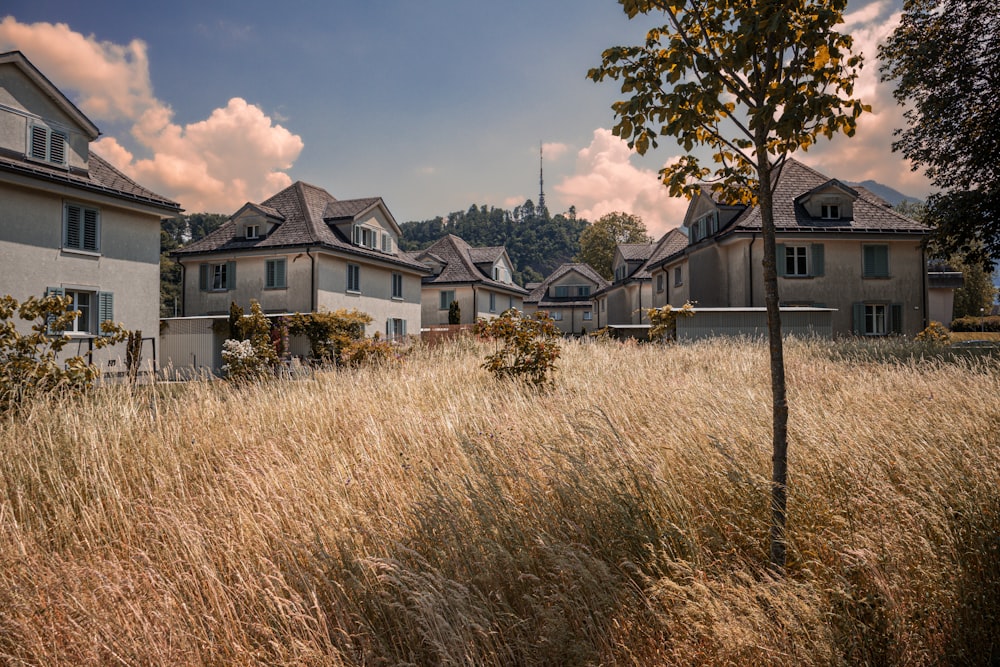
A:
399 199 589 285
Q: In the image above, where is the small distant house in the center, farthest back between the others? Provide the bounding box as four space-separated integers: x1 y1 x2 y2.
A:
524 264 610 334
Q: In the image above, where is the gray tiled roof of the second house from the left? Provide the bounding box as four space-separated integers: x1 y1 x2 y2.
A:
174 181 427 273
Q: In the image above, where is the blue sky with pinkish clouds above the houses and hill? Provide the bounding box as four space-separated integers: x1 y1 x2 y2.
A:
0 0 929 237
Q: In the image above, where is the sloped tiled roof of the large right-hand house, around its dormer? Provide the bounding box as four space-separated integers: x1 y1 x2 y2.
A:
724 159 928 234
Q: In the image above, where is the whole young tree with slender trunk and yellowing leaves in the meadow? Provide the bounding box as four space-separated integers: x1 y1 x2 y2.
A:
588 0 867 573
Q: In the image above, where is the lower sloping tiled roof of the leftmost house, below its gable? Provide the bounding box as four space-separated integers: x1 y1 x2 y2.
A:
0 151 181 214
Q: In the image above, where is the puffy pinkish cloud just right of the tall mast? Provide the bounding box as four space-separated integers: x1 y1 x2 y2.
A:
555 128 687 238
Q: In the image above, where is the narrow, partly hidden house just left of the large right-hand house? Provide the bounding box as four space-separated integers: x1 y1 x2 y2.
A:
594 229 687 328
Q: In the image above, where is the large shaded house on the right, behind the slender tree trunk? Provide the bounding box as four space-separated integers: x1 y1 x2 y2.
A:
647 159 928 336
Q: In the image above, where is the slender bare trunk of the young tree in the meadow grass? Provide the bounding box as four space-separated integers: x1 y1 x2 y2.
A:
758 160 788 576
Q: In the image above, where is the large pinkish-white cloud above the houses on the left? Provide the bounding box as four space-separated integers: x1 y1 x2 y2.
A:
0 16 303 213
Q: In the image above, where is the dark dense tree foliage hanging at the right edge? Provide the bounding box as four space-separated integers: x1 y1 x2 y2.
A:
879 0 1000 270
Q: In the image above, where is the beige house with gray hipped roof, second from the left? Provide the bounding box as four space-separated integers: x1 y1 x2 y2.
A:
173 181 430 338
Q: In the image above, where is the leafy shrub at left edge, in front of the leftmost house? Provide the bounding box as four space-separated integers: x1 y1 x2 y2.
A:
0 295 128 413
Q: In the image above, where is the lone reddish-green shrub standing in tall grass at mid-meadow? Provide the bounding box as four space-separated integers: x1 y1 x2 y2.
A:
475 308 561 387
